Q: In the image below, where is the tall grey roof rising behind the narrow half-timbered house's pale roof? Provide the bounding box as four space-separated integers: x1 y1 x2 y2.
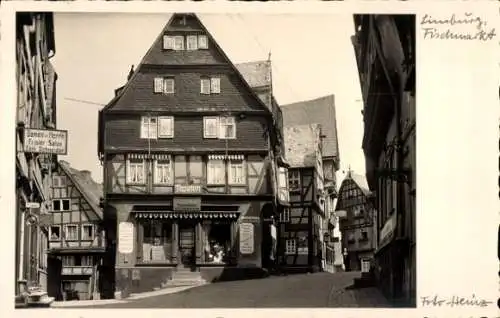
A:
281 95 339 158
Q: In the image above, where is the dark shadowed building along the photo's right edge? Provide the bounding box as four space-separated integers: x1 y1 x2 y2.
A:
353 15 416 306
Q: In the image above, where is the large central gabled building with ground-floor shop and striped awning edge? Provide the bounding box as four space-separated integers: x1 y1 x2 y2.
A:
98 13 286 294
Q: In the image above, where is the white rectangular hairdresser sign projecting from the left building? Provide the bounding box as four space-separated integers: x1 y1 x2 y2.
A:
23 128 68 155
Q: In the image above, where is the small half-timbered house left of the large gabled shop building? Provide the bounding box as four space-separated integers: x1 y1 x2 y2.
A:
47 161 105 300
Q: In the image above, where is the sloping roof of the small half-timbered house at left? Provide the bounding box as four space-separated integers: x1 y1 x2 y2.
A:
59 160 103 220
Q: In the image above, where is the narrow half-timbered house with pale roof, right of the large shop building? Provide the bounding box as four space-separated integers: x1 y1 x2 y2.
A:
278 124 326 272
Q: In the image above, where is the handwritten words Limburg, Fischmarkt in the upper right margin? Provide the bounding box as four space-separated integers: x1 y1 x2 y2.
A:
420 12 497 42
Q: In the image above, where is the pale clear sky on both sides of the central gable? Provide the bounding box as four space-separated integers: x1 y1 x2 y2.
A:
52 13 365 186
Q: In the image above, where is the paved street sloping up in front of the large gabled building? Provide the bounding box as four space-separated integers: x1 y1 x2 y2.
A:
73 273 391 308
